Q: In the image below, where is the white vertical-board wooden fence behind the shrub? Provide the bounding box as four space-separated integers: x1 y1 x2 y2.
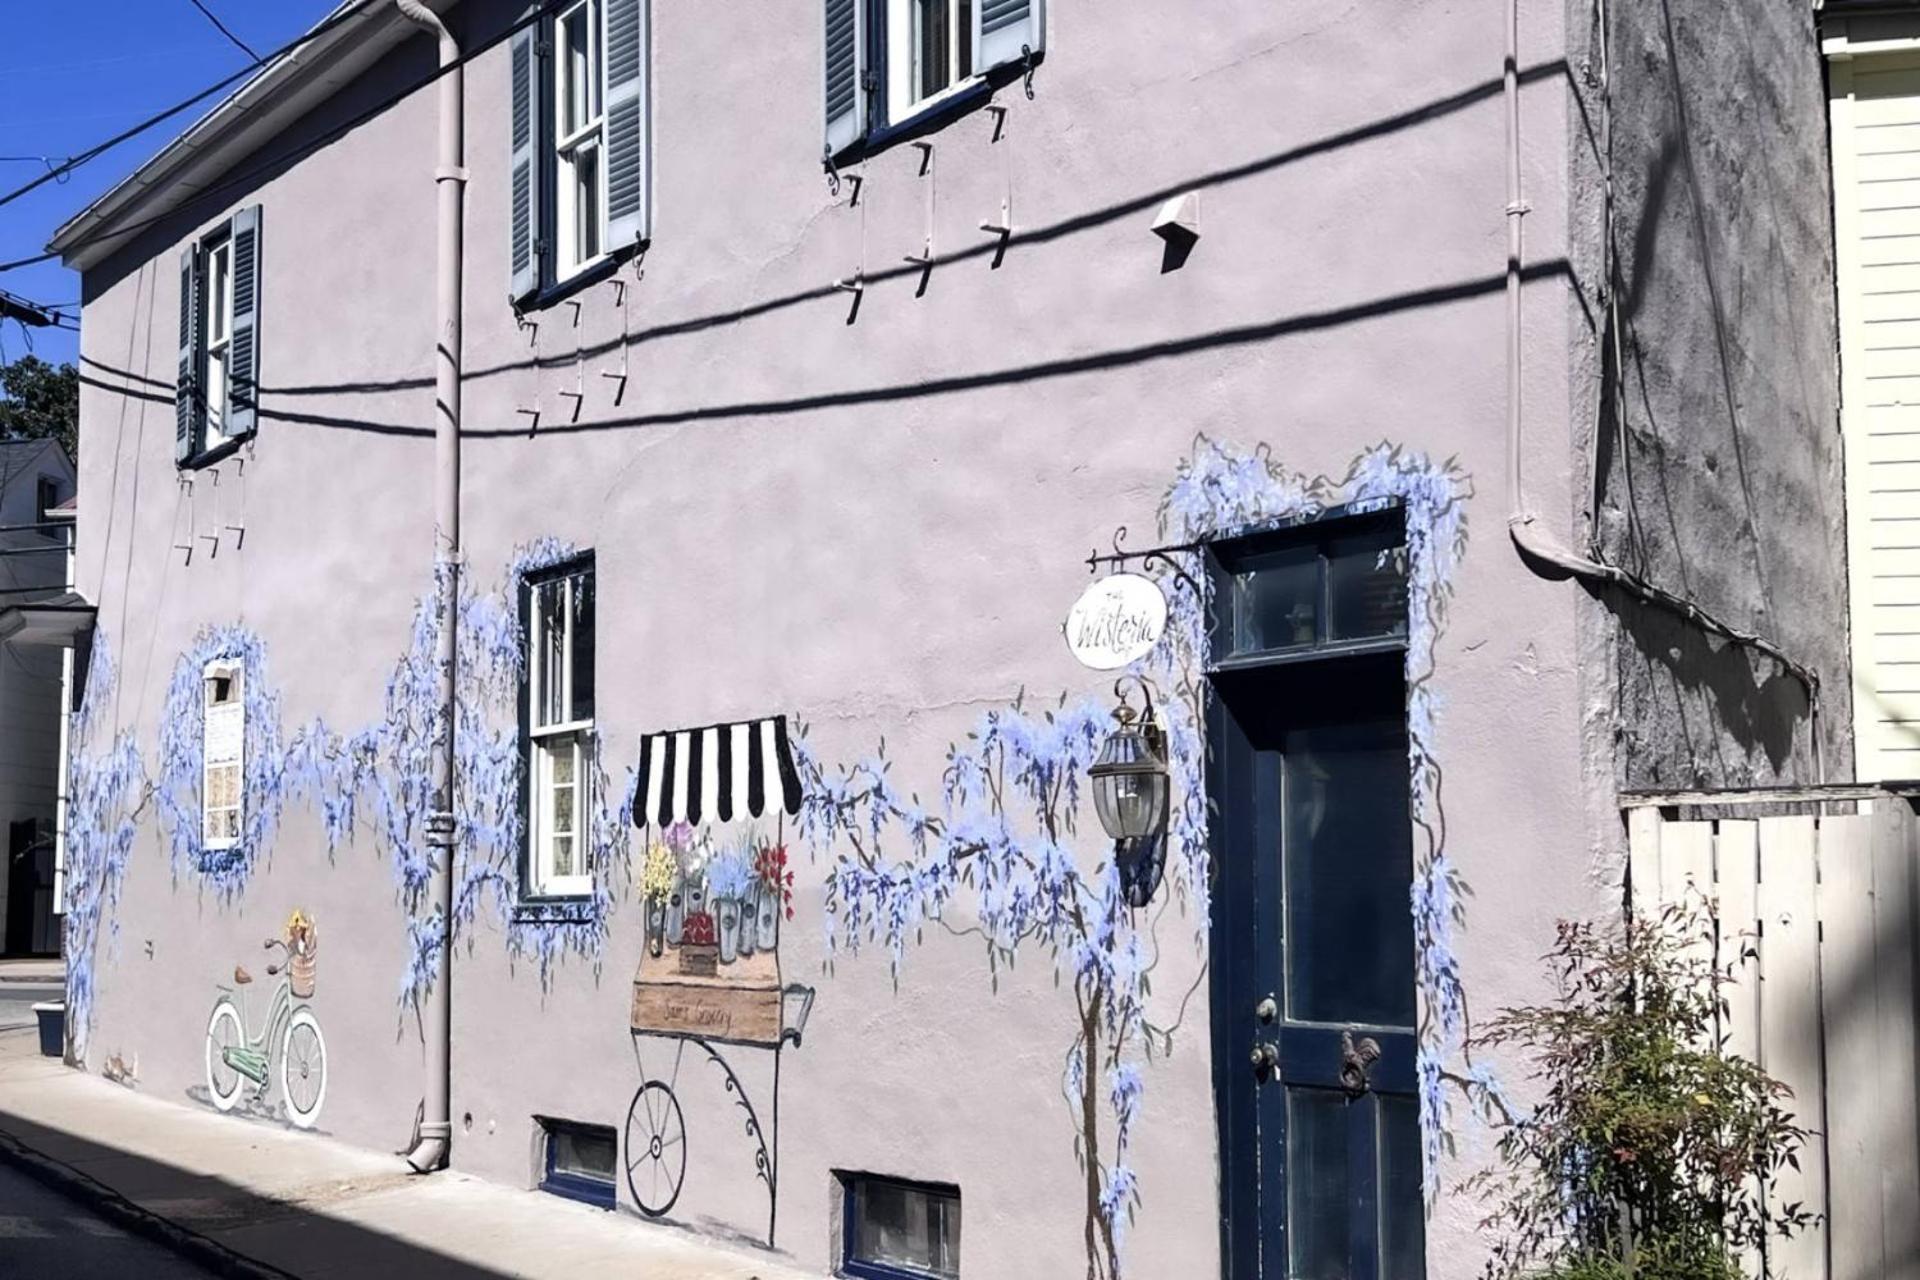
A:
1628 798 1920 1280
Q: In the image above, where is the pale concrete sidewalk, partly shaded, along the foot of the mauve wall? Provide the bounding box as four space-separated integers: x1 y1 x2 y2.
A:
0 1031 816 1280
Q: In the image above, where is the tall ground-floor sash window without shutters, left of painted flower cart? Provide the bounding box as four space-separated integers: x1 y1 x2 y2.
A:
526 564 593 898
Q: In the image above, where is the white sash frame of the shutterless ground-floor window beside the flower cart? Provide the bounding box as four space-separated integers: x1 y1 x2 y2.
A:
526 570 593 898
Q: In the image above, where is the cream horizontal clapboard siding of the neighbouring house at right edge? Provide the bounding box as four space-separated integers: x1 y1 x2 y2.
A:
1828 54 1920 781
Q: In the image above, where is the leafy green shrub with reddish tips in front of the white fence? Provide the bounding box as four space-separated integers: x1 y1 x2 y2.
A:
1471 908 1812 1280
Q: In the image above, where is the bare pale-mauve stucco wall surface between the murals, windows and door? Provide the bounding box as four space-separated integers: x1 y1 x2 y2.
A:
60 0 1607 1280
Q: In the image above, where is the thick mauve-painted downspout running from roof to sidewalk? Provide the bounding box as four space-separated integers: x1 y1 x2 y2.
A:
394 0 467 1173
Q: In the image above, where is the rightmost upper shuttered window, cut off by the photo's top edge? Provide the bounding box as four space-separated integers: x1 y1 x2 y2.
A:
824 0 1046 159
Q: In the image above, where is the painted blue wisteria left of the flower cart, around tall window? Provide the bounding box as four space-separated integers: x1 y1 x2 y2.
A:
67 539 632 1074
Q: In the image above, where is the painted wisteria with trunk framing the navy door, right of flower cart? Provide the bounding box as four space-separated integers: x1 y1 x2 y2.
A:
801 438 1496 1280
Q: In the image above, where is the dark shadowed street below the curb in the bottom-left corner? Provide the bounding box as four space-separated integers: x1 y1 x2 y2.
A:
0 1165 213 1280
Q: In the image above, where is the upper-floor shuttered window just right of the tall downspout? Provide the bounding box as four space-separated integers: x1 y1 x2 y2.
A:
507 0 649 307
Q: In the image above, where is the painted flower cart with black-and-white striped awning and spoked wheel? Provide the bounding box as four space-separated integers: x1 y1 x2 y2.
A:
622 716 814 1245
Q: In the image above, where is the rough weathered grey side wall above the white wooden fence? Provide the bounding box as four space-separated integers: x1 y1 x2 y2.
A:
1569 0 1853 787
